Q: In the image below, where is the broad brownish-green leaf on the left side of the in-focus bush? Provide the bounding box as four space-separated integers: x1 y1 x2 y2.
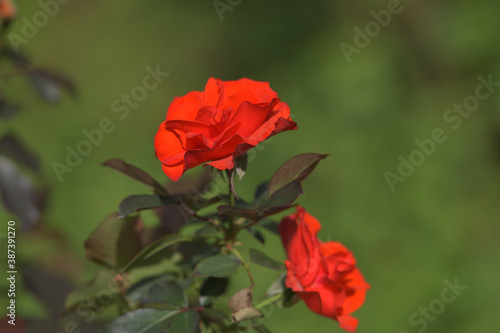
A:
85 214 142 269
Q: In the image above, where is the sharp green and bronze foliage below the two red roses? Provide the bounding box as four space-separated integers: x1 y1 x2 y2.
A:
66 153 326 333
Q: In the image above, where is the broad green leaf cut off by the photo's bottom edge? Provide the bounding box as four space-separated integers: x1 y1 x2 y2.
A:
103 309 199 333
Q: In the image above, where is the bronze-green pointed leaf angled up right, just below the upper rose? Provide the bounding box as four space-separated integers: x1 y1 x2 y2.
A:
268 153 328 198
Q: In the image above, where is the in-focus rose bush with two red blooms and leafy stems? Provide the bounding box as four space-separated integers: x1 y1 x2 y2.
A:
67 76 369 333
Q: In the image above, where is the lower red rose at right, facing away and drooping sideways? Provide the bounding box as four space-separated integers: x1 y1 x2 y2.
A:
279 207 370 332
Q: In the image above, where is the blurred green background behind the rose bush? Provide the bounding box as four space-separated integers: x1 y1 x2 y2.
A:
0 0 500 333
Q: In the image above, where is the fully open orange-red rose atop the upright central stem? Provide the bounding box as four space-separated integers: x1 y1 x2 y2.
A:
155 78 297 181
